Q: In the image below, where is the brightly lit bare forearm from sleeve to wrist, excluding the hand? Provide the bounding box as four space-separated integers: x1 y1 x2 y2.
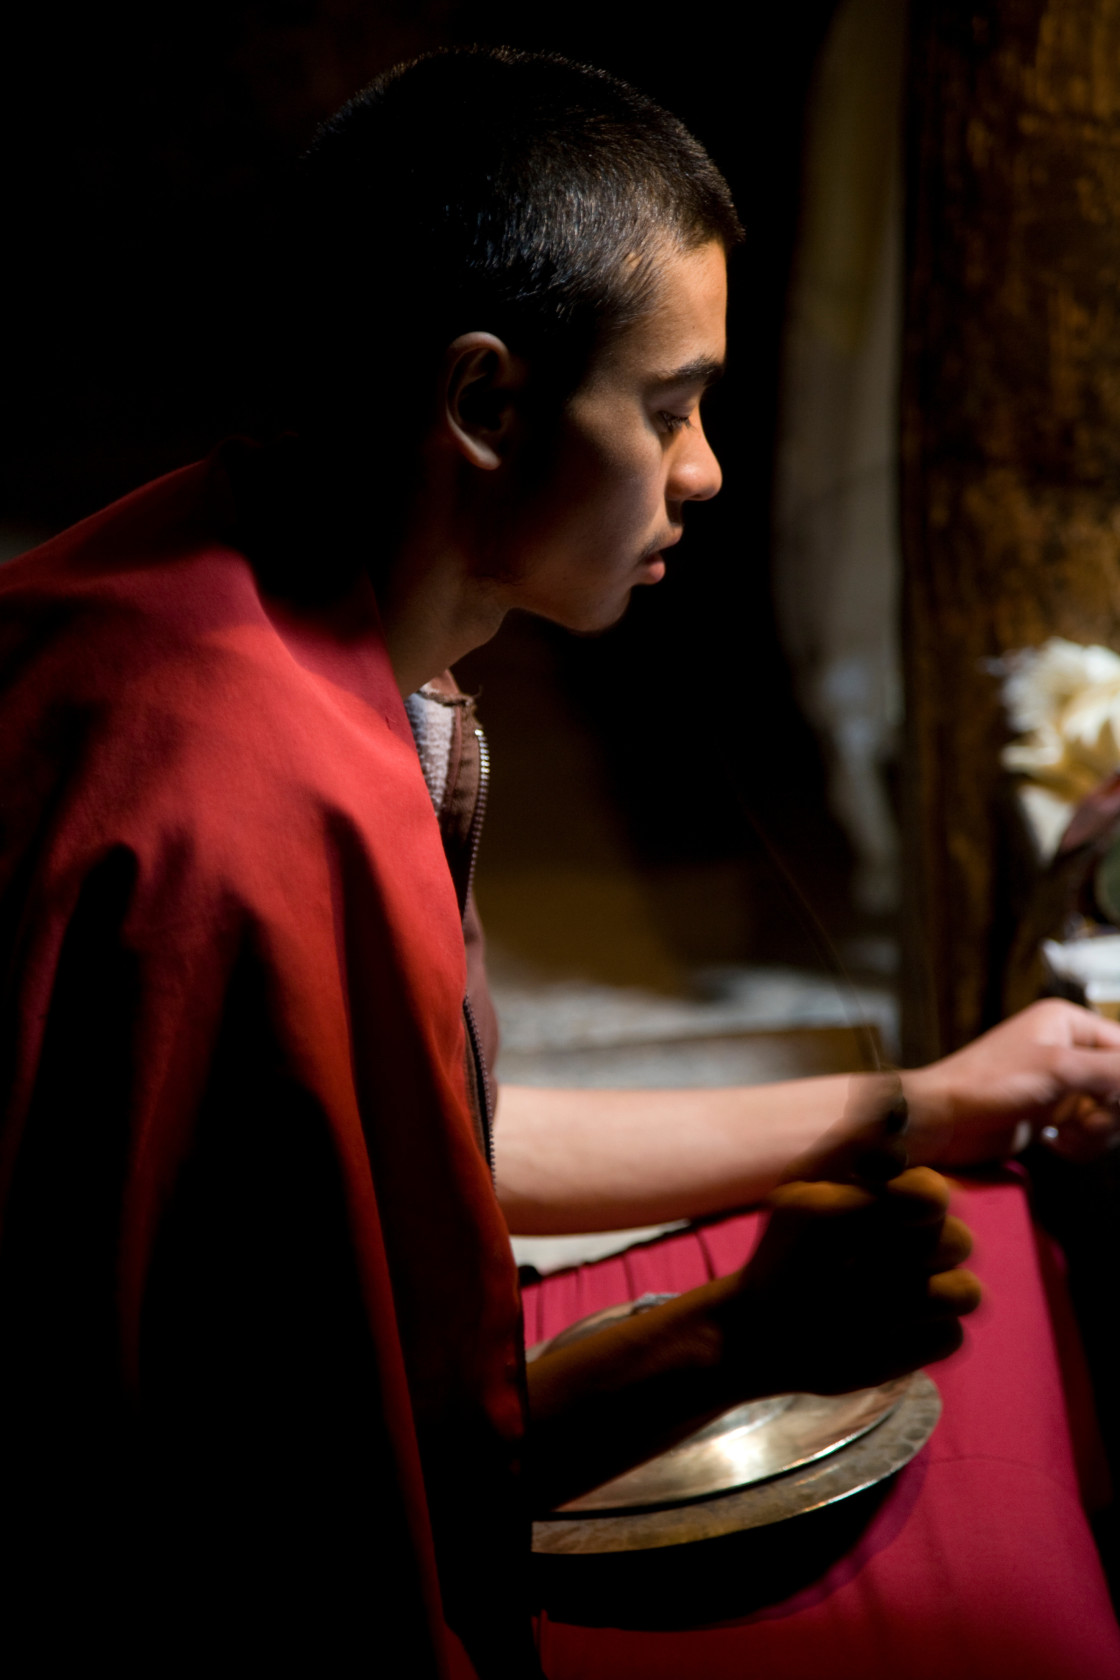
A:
495 1074 851 1235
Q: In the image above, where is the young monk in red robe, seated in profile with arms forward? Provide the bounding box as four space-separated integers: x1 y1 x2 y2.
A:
0 42 1120 1677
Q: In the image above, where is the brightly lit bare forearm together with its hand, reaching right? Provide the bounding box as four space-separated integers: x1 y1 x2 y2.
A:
495 998 1120 1235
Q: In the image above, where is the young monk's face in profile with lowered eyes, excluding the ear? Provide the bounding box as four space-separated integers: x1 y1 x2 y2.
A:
504 244 727 632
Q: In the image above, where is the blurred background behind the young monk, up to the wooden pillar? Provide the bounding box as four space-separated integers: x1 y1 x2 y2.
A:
0 0 903 1082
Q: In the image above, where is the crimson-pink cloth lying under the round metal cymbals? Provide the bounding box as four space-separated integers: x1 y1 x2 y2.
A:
526 1173 1120 1680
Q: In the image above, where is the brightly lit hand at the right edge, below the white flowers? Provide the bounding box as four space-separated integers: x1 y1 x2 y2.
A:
903 998 1120 1166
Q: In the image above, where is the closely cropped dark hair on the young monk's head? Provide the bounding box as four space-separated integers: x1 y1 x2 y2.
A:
272 47 742 427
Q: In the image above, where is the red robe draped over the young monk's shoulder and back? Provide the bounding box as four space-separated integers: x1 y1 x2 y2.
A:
0 464 531 1677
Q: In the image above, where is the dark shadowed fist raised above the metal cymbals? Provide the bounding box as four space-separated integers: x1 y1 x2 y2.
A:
725 1079 981 1394
